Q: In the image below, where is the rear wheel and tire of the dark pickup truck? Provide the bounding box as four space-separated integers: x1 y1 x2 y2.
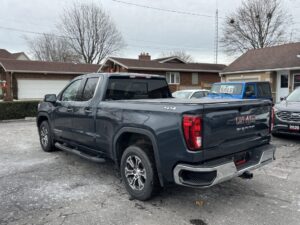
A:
121 145 159 201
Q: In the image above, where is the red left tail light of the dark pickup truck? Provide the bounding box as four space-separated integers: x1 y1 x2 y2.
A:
182 115 202 151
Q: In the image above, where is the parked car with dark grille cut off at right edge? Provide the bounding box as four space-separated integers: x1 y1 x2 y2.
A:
272 87 300 135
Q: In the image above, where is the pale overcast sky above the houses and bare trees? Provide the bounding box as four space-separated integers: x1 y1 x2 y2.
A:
0 0 300 64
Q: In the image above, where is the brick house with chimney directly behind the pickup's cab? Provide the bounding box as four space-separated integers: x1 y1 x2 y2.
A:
100 53 226 92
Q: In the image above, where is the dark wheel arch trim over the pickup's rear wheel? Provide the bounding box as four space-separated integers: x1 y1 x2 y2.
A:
112 127 163 187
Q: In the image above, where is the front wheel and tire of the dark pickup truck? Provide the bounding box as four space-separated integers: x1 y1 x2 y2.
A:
39 121 55 152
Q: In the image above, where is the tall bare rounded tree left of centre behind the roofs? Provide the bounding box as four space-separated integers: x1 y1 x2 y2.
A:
59 3 124 64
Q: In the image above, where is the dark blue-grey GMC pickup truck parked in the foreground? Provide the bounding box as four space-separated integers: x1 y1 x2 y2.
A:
37 74 275 200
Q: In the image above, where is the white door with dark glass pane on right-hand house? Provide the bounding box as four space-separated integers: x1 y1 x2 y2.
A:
276 71 290 102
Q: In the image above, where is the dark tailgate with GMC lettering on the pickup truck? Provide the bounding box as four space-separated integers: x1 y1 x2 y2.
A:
202 100 272 160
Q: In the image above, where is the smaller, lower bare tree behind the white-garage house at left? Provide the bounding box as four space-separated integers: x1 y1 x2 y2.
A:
26 34 81 62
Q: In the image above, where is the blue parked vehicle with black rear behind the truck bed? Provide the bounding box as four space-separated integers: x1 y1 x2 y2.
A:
208 81 273 101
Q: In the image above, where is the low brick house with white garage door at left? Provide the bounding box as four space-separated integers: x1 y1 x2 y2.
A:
0 58 100 101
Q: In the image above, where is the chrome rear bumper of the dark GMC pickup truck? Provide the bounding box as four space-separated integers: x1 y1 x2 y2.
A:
173 144 275 188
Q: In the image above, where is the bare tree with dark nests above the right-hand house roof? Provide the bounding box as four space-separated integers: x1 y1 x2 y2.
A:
221 0 292 55
